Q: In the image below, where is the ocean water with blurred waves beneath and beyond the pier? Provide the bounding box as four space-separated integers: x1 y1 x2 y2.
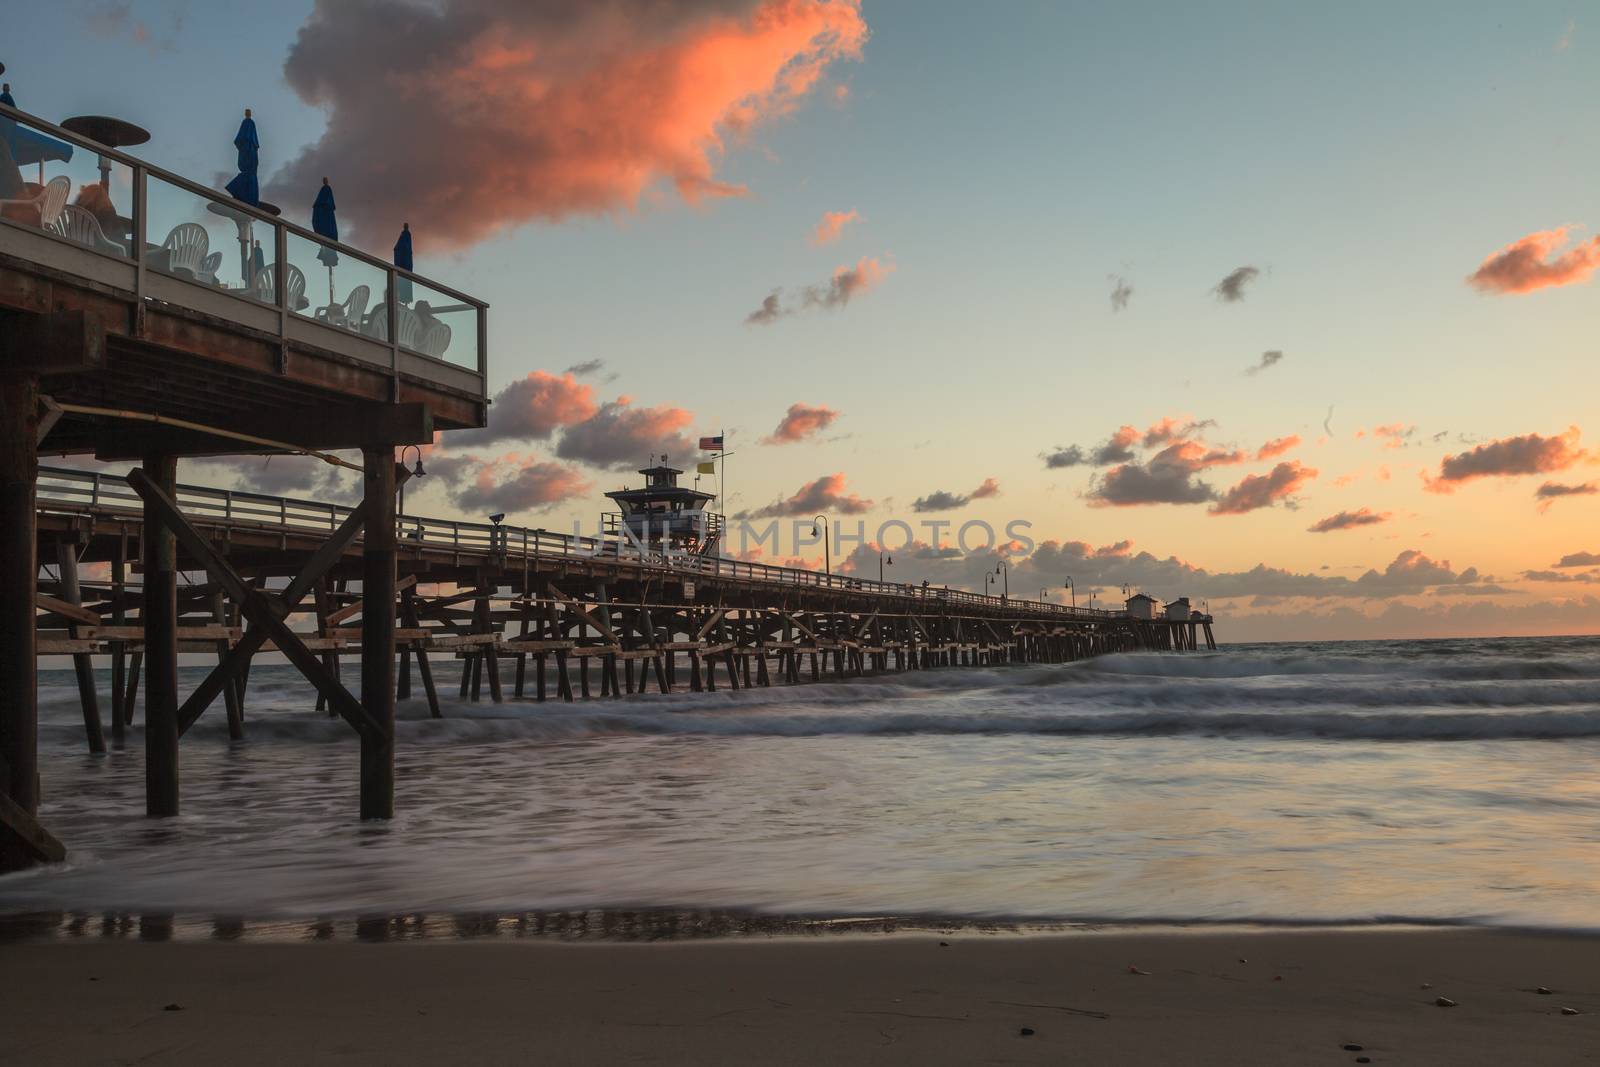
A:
0 638 1600 929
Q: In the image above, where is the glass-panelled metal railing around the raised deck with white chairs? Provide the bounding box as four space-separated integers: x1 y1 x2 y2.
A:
0 104 488 388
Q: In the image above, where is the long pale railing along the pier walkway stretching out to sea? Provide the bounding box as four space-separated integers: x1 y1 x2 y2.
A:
38 467 1126 619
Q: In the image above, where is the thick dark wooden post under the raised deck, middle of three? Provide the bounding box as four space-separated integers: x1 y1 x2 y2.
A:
139 456 181 817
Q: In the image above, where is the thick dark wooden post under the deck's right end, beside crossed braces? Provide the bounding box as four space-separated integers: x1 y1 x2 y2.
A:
362 446 395 819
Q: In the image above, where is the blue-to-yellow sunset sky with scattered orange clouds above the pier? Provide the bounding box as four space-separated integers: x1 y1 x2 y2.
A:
12 0 1600 640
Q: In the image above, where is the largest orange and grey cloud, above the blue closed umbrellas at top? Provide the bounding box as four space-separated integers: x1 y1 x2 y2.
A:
270 0 867 250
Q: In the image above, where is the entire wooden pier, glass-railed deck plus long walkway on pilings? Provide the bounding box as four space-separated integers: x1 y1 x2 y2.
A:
0 106 1216 870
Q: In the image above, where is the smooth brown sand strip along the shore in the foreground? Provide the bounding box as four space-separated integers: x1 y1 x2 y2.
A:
0 929 1600 1064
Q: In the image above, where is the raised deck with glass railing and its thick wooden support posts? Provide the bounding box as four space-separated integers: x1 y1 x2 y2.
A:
0 106 488 870
